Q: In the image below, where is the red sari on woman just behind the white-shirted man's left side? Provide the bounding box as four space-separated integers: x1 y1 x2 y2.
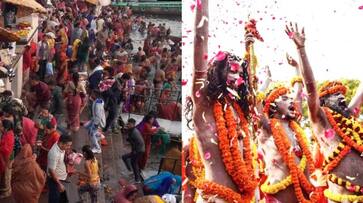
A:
37 130 60 171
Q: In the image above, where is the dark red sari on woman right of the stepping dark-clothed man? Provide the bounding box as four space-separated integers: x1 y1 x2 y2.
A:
139 122 158 169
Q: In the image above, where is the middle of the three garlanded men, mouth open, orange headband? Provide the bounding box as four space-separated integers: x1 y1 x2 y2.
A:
257 56 322 203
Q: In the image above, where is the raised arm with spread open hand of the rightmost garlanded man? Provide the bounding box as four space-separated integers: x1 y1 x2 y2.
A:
285 23 320 123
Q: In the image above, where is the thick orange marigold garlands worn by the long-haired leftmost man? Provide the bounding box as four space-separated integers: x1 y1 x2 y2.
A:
189 102 258 203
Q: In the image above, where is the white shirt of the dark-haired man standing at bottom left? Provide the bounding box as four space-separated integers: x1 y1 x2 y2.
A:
47 142 67 180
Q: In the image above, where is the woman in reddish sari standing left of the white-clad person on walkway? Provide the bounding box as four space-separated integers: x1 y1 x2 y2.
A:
64 72 86 132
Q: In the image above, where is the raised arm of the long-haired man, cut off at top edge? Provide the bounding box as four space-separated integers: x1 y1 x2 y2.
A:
192 0 209 106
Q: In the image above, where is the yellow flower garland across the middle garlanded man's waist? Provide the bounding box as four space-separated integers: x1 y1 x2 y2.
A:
261 156 307 194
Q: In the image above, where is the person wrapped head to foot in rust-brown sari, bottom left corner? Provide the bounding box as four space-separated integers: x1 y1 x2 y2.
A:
11 144 46 203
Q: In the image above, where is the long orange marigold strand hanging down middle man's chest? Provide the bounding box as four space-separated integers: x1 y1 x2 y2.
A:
271 119 311 203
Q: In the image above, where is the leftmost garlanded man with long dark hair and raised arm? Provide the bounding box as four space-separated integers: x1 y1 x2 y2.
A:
185 0 258 203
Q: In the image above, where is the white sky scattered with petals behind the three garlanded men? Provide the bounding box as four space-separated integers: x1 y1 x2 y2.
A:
182 0 363 143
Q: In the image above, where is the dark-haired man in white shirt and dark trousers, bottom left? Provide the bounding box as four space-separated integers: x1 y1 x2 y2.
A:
47 135 72 202
